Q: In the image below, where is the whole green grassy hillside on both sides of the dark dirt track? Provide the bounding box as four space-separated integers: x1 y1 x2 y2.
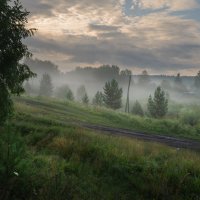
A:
0 97 200 200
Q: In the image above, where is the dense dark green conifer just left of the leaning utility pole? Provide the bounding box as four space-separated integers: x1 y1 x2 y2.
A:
103 79 123 109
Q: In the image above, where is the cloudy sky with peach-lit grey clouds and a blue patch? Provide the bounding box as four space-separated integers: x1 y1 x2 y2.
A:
21 0 200 75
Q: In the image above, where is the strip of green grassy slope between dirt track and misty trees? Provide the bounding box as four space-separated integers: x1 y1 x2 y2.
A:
16 95 200 140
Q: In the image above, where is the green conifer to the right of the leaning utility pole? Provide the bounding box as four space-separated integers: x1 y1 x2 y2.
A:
147 87 168 118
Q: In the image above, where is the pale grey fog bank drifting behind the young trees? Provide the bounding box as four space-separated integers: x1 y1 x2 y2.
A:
25 59 200 107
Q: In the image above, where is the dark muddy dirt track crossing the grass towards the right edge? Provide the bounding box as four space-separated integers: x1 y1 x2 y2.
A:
83 125 200 151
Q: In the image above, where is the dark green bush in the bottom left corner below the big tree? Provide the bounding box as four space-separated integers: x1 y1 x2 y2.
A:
0 125 26 199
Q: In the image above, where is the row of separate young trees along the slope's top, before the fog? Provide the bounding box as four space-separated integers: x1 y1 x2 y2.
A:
25 74 168 118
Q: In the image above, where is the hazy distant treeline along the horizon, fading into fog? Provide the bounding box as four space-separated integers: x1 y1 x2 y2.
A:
25 58 200 92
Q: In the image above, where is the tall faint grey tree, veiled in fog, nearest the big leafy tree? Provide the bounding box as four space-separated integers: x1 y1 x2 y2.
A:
39 74 53 97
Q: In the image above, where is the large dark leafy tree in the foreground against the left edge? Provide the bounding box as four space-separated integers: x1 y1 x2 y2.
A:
0 0 35 123
